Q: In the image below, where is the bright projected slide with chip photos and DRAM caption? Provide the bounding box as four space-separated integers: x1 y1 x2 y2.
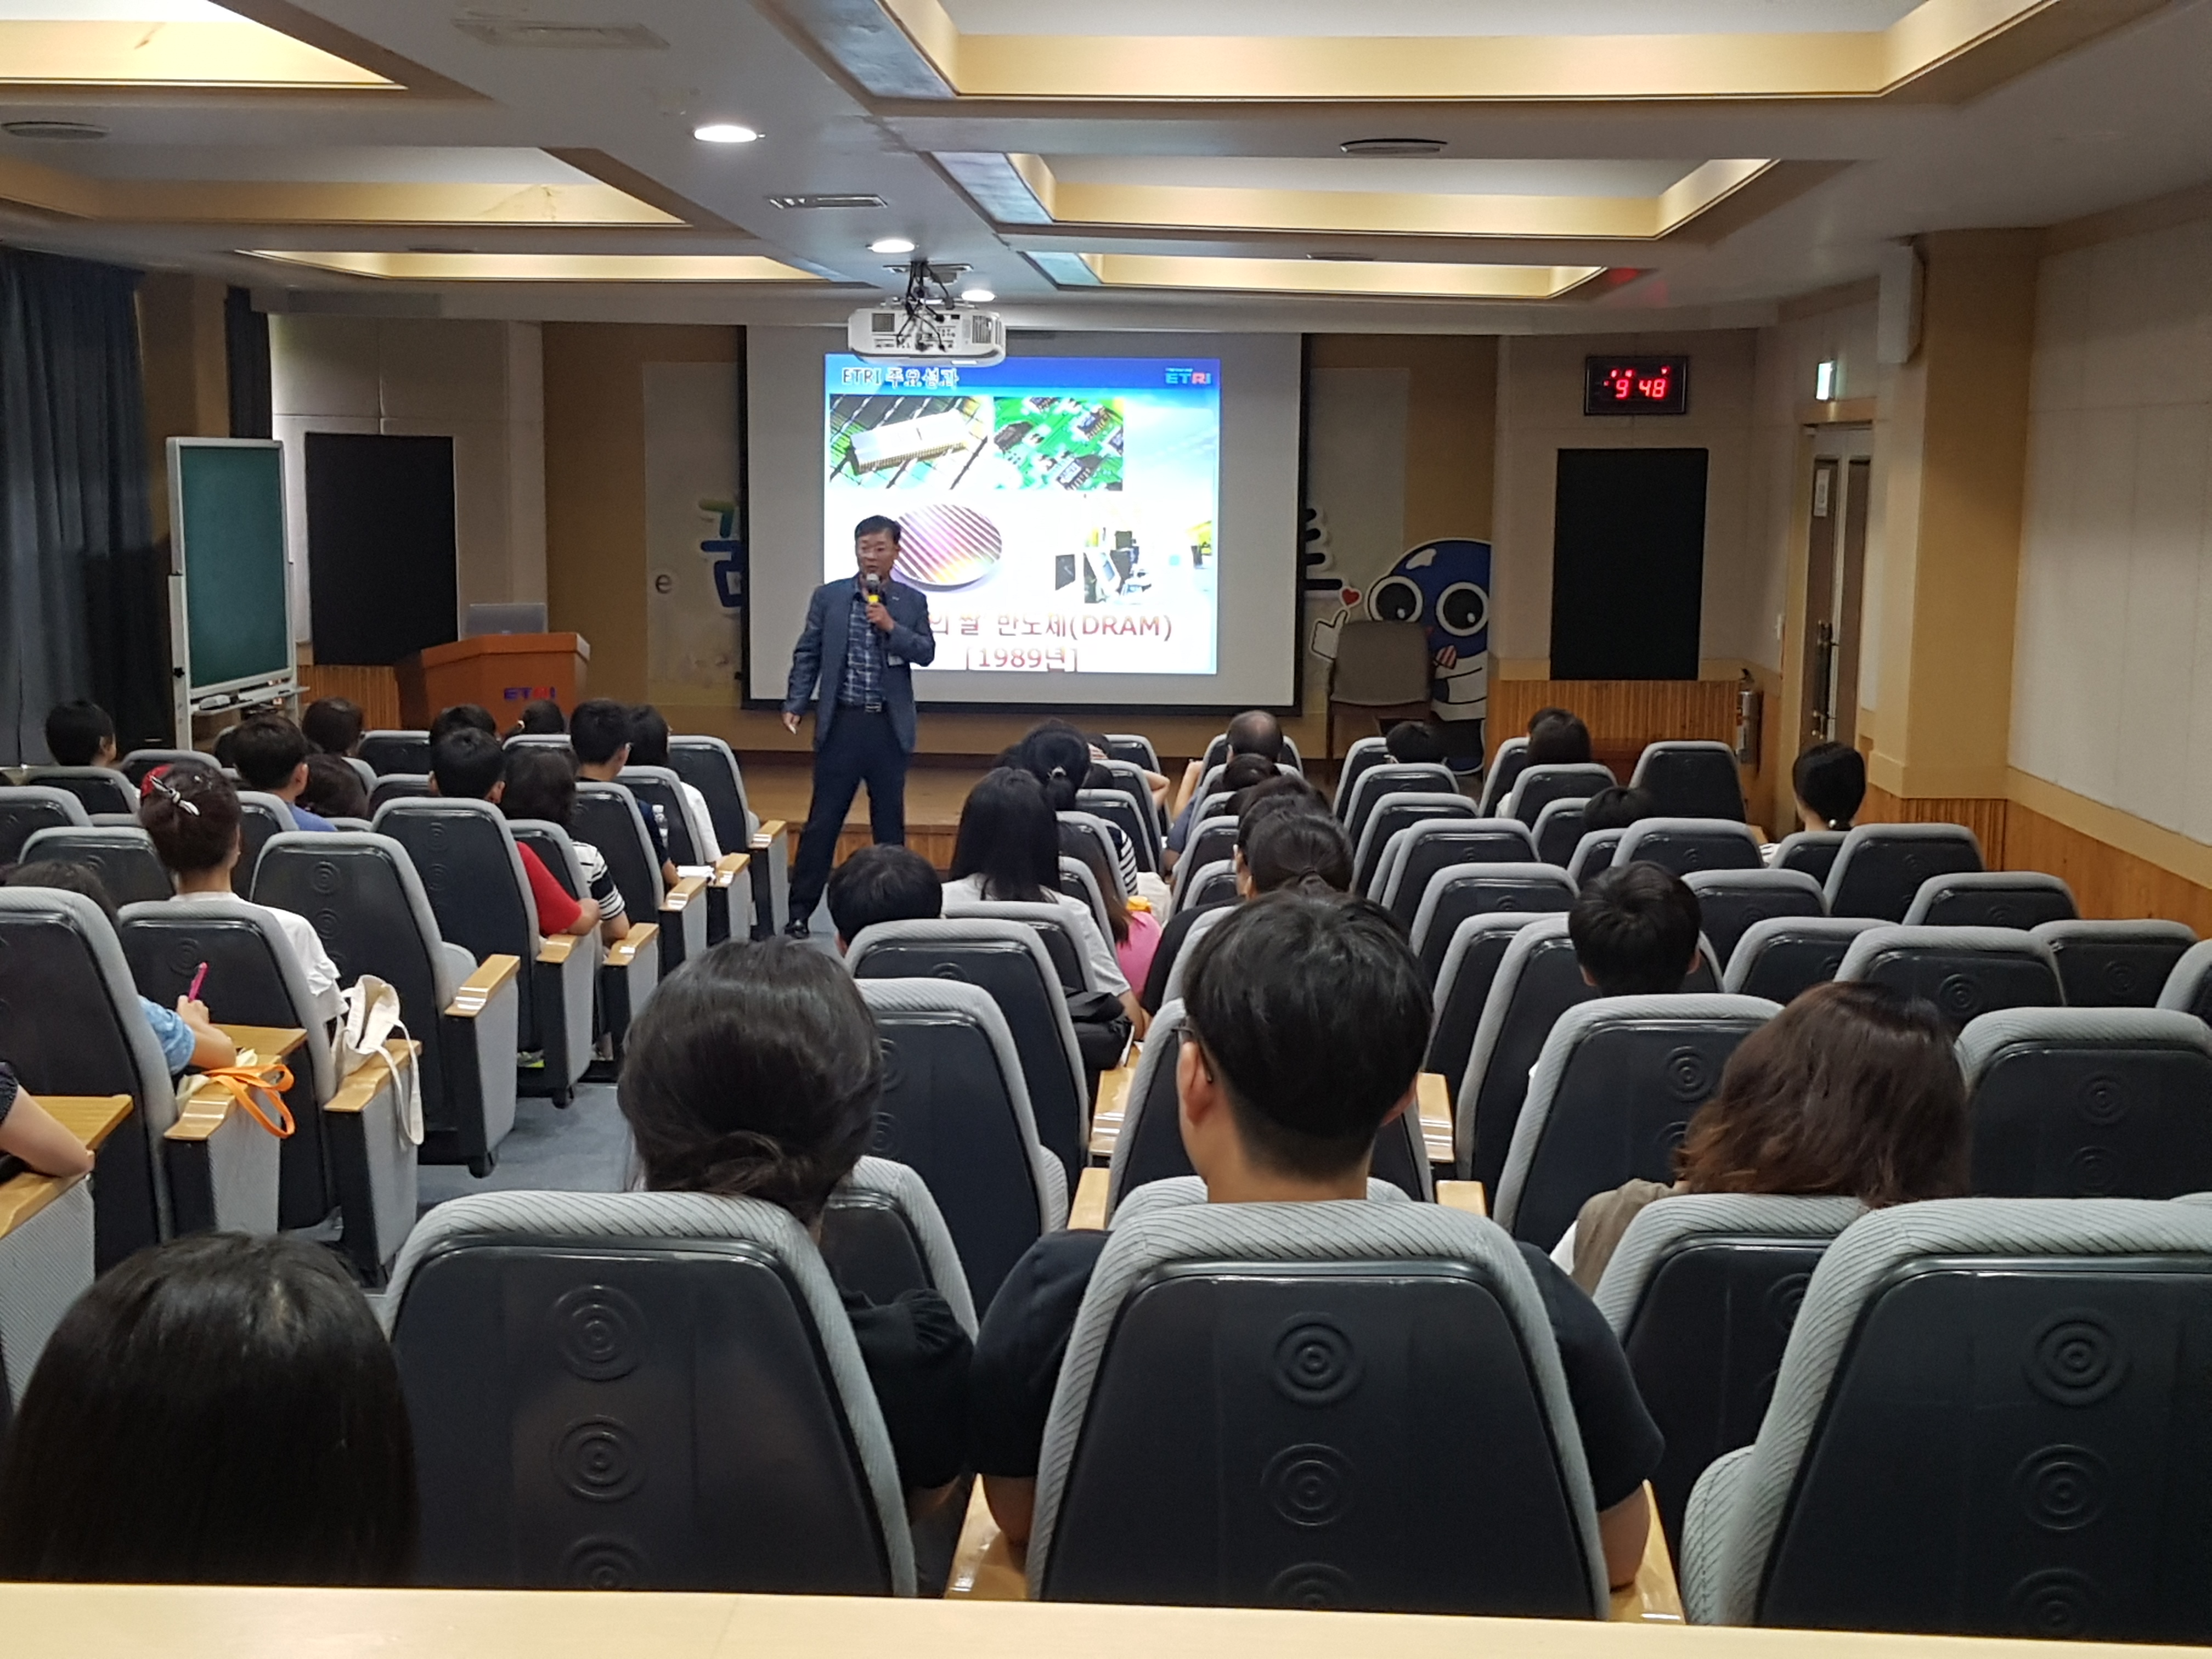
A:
823 356 1221 675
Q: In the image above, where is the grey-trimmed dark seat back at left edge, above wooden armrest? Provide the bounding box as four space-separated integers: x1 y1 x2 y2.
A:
0 889 177 1269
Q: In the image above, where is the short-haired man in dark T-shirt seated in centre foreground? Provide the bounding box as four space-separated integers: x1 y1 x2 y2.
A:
969 894 1661 1584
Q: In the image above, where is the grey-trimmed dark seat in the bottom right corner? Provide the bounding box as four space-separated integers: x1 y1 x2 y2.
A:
1681 1199 2212 1644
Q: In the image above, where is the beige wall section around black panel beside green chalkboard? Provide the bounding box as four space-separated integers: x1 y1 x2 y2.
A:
270 314 546 654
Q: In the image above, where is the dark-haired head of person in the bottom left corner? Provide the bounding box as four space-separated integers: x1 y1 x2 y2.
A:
0 1232 418 1586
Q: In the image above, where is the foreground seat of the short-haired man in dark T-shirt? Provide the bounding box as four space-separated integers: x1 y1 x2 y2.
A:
1026 1201 1608 1619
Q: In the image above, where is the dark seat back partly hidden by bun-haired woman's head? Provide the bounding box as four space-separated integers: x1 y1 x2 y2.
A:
860 973 1068 1307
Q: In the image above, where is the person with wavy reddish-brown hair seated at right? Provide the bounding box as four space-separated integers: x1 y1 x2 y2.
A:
1553 982 1968 1290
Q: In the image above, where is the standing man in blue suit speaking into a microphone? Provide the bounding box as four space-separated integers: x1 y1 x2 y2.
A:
783 517 938 938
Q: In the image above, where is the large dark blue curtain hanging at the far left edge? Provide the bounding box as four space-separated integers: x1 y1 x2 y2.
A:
0 248 168 761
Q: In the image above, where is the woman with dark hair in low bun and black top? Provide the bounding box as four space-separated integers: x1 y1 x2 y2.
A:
617 942 969 1509
